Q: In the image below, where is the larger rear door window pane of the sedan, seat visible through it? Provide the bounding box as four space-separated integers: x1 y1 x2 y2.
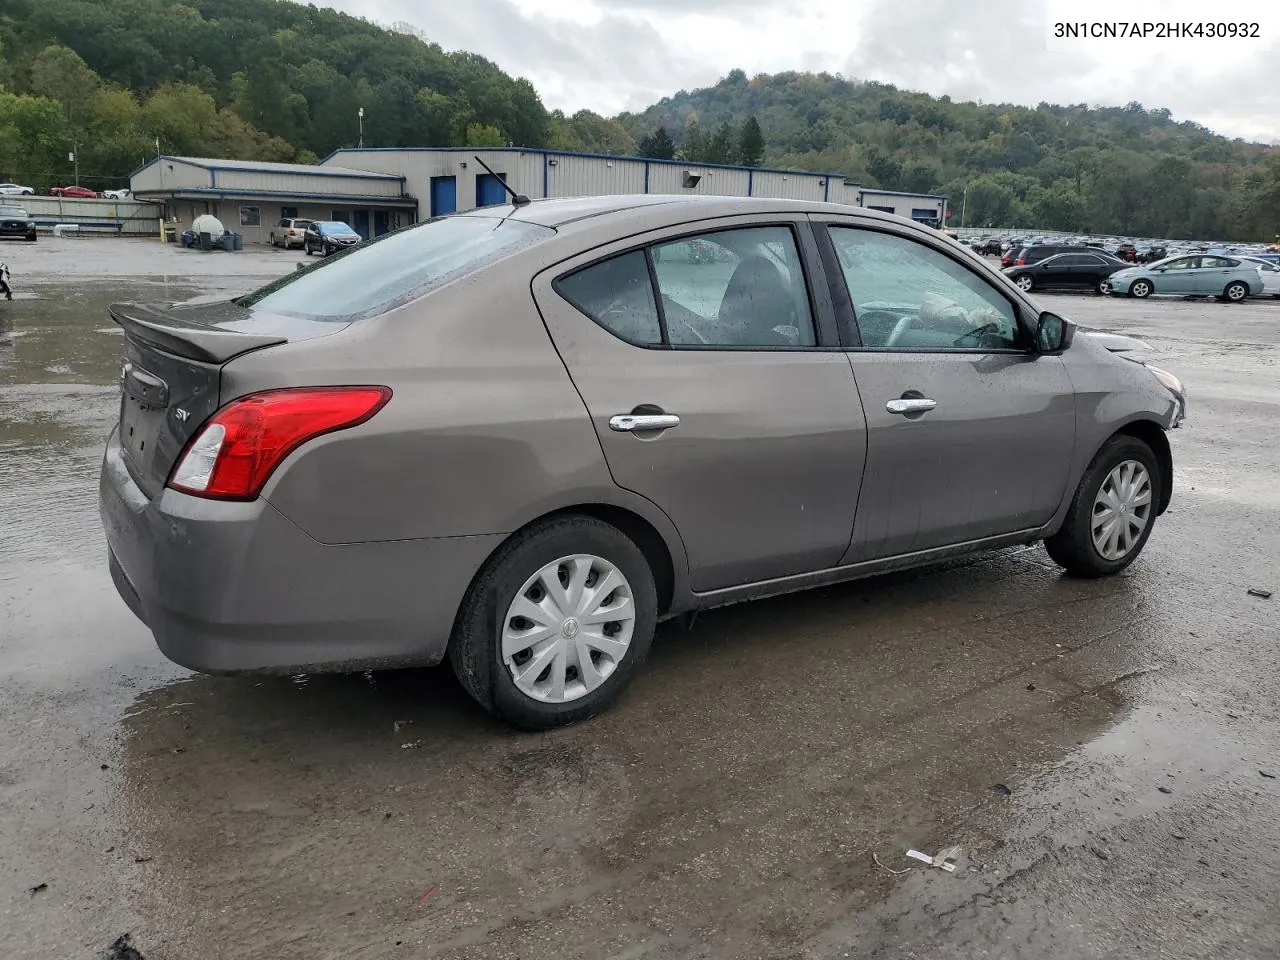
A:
652 227 817 347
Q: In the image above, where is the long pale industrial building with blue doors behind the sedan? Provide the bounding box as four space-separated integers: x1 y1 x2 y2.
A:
131 147 946 243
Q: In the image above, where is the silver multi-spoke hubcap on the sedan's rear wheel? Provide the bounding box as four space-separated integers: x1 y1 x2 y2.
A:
502 554 636 703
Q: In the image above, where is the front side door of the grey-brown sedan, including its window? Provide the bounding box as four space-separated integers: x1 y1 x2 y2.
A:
819 218 1075 562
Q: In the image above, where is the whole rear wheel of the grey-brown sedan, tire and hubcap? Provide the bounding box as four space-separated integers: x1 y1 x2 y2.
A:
449 516 658 730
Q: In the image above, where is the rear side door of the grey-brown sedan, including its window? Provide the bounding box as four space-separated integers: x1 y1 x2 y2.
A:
524 218 867 591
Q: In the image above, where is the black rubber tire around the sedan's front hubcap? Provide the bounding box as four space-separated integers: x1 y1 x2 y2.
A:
1044 434 1161 577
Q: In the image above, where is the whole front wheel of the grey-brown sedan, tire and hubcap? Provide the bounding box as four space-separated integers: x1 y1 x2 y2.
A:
1044 435 1161 577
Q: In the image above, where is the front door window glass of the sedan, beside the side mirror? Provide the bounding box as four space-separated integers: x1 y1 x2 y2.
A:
831 225 1020 351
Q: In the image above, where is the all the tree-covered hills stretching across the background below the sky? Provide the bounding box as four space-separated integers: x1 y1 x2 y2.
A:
0 0 1280 239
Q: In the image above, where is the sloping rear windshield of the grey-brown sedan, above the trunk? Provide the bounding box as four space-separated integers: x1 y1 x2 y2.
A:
236 216 556 321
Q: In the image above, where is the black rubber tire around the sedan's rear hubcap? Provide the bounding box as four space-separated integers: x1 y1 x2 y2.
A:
449 516 658 730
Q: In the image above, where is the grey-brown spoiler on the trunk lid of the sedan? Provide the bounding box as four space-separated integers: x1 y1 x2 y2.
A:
108 302 289 364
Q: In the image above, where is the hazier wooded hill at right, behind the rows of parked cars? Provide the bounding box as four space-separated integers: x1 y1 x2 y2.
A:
618 70 1280 239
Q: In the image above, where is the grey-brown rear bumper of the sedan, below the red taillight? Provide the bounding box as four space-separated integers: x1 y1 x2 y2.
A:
99 431 503 673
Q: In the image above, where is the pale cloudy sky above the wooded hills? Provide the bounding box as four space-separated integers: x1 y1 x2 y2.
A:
319 0 1280 142
